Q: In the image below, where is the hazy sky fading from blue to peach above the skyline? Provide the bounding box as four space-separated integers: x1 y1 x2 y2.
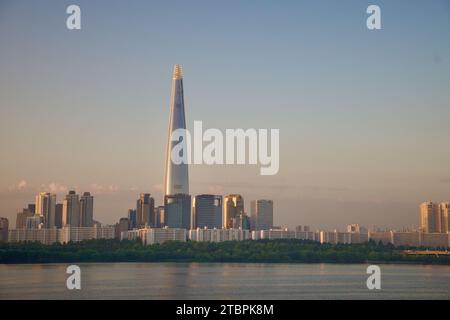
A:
0 0 450 230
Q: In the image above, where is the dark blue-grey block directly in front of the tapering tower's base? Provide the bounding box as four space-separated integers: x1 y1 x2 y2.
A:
164 193 191 229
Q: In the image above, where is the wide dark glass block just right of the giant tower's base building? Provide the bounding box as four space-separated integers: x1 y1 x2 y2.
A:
192 194 222 229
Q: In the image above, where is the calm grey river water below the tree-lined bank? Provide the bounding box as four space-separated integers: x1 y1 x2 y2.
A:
0 263 450 300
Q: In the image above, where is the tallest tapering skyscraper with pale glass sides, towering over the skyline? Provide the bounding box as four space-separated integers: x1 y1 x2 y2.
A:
164 64 189 195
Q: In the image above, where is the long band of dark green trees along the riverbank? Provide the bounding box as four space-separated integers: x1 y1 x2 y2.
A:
0 239 450 264
